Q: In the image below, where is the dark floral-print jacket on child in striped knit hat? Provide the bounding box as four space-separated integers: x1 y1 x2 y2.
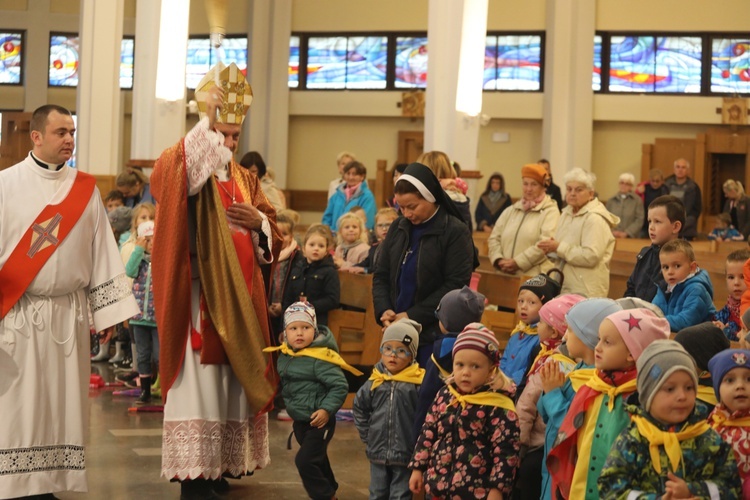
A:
409 386 520 499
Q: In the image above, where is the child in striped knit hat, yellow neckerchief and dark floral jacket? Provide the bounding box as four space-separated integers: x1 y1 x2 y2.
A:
409 325 519 499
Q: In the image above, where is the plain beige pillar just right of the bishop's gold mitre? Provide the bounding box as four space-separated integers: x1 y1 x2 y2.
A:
247 0 292 188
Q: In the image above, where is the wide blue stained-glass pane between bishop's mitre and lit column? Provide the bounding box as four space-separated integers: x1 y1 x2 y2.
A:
307 36 388 89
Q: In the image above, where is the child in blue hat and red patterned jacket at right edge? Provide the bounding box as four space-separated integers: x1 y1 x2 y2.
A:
708 349 750 498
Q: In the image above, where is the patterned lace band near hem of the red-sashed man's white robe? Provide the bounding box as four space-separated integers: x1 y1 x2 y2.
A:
0 444 86 476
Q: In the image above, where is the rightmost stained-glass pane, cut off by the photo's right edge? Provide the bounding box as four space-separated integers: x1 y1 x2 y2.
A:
711 38 750 94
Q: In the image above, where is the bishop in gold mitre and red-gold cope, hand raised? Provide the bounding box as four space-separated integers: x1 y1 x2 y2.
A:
151 63 282 500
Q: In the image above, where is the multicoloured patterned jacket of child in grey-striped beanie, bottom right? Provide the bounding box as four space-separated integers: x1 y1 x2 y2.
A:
598 402 742 500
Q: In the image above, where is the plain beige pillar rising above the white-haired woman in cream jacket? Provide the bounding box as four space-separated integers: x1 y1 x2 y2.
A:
542 0 596 179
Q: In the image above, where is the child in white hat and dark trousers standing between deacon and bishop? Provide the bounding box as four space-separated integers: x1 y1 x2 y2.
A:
125 221 159 405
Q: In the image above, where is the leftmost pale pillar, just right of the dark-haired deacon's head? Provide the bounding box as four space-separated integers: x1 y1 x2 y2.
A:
76 0 125 175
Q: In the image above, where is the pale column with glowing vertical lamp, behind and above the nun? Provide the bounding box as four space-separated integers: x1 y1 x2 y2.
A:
424 0 487 170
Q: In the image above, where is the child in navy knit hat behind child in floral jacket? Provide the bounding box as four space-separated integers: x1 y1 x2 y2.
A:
414 286 485 439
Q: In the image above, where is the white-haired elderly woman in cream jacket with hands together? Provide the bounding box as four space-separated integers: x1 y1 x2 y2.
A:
537 168 620 297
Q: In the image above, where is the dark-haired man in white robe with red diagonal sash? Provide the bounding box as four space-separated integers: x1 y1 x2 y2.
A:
0 104 138 499
